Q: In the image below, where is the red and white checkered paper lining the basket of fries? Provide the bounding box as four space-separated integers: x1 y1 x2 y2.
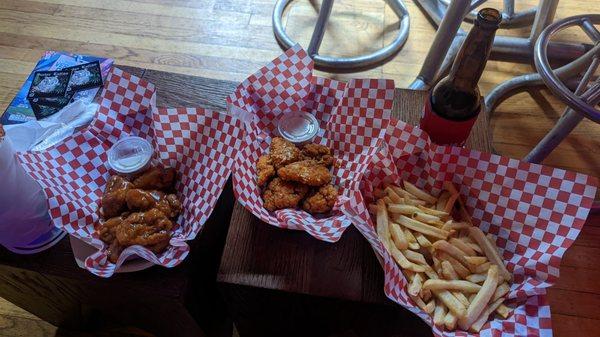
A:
344 120 598 336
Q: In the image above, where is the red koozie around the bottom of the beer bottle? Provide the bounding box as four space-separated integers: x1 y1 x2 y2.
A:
419 96 479 146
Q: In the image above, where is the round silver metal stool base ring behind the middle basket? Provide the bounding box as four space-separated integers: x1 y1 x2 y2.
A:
273 0 410 72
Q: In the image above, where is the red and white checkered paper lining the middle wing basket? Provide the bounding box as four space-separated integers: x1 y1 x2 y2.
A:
227 45 394 242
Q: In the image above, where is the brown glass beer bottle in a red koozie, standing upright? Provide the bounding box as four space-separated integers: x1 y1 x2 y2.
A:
420 8 502 146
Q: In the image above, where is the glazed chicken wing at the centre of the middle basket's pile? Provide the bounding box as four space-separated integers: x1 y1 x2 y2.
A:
277 159 331 187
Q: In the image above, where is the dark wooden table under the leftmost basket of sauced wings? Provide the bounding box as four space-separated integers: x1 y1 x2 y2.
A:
0 67 241 336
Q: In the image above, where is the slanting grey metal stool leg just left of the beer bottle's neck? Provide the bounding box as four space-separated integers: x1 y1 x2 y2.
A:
409 0 471 89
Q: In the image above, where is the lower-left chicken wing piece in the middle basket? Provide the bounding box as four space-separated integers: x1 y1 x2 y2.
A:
263 178 308 212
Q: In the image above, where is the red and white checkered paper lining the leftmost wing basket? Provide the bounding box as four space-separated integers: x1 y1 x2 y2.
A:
19 68 244 277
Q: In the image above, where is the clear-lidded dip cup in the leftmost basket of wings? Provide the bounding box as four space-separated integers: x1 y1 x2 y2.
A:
108 136 154 174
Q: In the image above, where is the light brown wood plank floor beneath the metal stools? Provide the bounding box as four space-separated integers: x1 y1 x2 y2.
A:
0 0 600 336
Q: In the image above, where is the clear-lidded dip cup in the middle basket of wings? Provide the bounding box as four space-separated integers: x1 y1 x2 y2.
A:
277 111 319 144
